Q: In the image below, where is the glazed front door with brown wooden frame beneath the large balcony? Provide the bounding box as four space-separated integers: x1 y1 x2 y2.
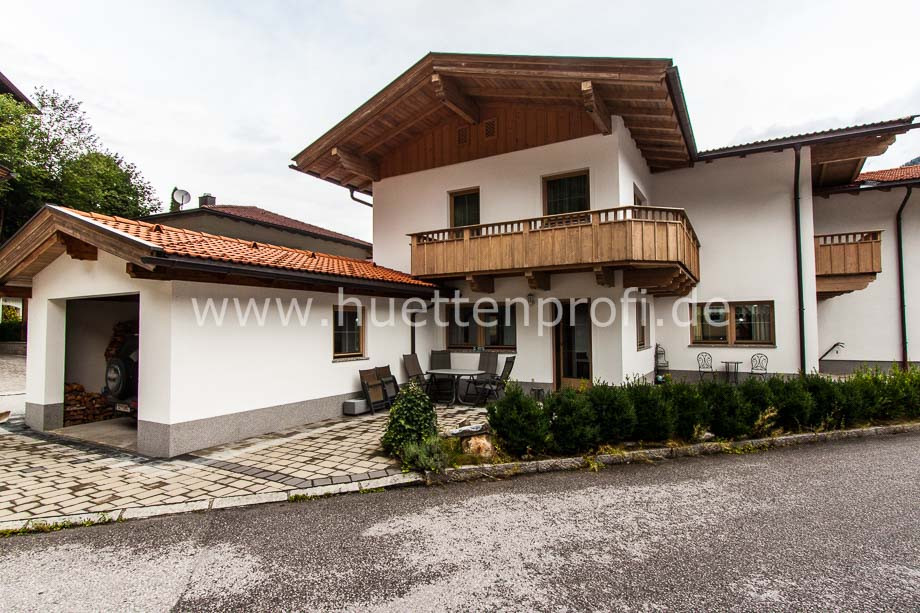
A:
553 302 591 389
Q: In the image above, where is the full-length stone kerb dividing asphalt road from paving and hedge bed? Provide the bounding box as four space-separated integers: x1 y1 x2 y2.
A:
0 422 920 534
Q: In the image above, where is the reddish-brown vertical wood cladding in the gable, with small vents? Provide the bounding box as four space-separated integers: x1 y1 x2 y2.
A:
380 102 600 178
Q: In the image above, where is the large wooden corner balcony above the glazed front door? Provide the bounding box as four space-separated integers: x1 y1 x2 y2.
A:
409 206 700 296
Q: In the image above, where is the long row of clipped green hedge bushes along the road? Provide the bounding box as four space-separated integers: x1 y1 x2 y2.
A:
488 368 920 456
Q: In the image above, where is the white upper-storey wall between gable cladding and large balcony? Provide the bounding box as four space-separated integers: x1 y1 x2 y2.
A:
374 135 620 272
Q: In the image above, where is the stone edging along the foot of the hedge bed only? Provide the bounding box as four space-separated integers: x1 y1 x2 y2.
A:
425 422 920 485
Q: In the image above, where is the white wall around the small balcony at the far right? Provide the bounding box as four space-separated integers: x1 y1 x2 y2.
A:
814 188 920 362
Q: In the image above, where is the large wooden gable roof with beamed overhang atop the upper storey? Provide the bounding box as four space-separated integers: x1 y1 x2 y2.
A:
291 53 696 194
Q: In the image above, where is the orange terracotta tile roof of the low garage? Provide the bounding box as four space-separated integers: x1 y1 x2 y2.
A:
63 207 434 287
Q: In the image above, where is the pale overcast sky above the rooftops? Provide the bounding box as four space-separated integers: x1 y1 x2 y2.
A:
0 0 920 240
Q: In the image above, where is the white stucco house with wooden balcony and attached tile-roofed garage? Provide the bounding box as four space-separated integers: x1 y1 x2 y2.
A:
0 53 920 455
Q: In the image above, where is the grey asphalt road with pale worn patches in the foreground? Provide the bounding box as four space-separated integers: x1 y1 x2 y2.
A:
0 435 920 611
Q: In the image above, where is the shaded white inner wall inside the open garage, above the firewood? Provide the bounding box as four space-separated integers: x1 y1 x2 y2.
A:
64 300 138 392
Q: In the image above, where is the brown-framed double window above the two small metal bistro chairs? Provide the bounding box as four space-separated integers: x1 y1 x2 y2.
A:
690 301 776 345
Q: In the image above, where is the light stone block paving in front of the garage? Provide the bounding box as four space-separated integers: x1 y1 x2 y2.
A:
0 407 484 522
